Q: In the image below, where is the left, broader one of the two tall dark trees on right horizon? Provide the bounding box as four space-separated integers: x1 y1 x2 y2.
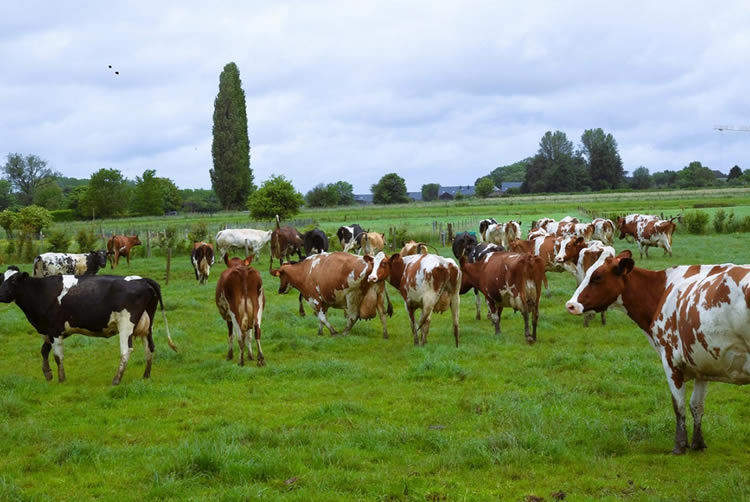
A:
521 131 590 193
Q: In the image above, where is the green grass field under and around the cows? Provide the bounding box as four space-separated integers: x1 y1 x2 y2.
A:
0 198 750 501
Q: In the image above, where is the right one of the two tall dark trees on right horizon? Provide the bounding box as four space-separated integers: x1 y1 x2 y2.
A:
581 128 625 190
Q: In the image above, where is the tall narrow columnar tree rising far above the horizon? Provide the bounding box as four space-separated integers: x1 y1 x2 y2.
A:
209 63 255 209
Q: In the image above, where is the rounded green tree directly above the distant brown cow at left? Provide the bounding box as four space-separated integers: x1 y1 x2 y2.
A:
78 169 130 218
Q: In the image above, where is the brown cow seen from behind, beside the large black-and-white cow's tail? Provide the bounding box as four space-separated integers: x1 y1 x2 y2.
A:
216 257 266 366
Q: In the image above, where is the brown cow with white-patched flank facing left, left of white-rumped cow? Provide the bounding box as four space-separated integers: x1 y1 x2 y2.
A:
271 252 393 338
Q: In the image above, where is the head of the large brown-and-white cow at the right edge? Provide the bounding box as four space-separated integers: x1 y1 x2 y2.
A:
565 250 635 315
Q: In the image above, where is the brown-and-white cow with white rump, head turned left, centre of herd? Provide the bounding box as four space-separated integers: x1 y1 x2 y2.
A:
368 253 461 347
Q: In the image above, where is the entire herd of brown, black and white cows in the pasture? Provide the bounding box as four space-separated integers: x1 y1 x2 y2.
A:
0 214 750 453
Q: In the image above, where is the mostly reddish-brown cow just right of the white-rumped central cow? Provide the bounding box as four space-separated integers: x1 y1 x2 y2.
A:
461 252 545 344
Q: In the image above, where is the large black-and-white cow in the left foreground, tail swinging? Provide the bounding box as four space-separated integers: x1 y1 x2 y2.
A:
0 272 177 385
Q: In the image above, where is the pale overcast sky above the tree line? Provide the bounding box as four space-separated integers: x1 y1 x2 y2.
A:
0 0 750 193
